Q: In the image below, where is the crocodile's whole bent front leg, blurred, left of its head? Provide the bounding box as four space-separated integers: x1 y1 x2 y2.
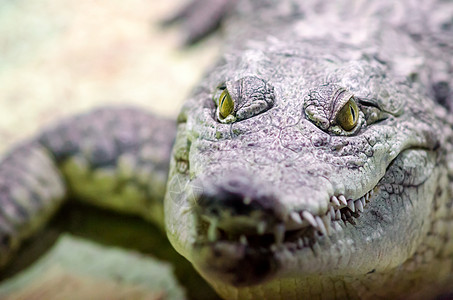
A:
0 108 175 265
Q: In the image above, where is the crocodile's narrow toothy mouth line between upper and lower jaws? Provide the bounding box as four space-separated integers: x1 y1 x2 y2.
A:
197 187 377 253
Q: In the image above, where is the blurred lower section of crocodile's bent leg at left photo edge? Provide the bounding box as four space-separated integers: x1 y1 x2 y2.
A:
0 142 66 266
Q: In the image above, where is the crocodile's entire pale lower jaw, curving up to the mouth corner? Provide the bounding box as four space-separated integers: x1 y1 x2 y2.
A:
166 150 438 290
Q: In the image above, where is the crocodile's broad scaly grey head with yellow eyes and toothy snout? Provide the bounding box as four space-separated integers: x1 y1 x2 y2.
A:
165 39 443 299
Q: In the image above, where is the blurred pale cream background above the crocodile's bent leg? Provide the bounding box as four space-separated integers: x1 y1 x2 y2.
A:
0 0 218 153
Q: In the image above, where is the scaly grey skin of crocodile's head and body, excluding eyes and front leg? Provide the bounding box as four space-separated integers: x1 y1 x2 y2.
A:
165 1 453 299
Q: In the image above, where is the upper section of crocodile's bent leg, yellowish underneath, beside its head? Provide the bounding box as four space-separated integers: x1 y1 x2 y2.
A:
39 107 176 228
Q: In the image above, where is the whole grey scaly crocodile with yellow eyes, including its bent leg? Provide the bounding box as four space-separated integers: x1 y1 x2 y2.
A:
0 0 453 299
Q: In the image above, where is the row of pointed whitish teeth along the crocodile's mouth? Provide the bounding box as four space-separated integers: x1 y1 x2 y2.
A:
208 190 374 245
